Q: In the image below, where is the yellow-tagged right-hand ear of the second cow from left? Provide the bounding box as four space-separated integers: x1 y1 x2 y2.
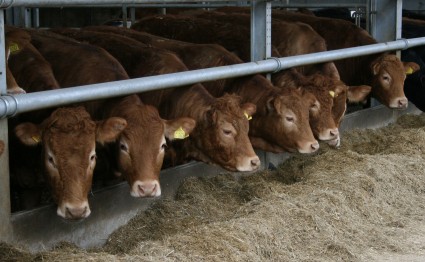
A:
164 117 196 140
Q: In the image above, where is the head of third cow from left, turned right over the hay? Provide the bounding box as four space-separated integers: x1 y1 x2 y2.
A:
188 94 260 171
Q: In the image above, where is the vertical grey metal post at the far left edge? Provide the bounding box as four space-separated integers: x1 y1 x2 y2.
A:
0 9 12 244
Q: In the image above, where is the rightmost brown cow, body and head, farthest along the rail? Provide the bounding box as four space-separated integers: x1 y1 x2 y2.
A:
215 7 419 109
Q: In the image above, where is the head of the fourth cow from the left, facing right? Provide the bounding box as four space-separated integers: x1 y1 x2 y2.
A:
250 88 320 153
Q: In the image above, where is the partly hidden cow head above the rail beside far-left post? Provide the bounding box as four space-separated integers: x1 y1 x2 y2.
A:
5 29 28 95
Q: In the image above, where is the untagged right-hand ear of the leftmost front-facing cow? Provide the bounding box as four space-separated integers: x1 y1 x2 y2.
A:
96 117 127 144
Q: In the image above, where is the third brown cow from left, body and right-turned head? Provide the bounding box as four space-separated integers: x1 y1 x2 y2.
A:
52 29 261 171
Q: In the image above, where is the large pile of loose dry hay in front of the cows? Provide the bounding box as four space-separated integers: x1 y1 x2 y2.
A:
4 114 425 261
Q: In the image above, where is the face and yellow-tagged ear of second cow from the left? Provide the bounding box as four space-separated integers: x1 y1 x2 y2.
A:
113 104 196 197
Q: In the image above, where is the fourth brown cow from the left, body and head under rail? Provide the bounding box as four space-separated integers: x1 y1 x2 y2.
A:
78 26 319 153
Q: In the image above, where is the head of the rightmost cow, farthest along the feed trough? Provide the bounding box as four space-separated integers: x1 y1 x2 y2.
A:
370 54 419 109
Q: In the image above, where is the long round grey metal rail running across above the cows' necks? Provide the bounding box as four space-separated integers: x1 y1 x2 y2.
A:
0 37 425 118
